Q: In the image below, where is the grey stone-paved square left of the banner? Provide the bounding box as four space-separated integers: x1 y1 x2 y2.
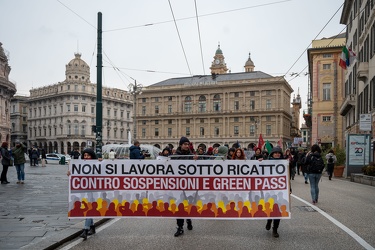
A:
0 163 103 250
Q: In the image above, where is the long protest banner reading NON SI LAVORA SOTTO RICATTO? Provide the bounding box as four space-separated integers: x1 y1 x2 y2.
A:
68 158 290 219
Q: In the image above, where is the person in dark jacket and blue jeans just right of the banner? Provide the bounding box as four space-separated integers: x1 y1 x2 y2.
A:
305 144 325 205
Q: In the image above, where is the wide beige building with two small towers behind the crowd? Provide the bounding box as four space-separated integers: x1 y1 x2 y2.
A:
136 47 300 147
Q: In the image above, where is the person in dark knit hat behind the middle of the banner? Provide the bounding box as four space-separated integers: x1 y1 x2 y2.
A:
171 136 198 237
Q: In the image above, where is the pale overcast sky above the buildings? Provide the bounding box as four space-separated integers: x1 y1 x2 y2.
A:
0 0 345 114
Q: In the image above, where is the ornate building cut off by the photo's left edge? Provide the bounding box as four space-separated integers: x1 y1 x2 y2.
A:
0 43 16 145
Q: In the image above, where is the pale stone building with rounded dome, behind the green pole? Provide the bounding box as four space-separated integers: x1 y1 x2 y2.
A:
28 53 133 153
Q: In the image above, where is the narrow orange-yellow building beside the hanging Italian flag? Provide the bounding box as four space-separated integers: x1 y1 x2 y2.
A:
307 33 346 149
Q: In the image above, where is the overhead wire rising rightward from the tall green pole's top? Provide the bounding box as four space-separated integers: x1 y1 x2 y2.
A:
103 0 292 33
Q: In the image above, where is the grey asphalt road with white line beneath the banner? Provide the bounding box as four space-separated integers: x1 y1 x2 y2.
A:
59 176 375 250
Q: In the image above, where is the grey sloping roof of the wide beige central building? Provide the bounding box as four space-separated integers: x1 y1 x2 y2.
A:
149 71 274 87
